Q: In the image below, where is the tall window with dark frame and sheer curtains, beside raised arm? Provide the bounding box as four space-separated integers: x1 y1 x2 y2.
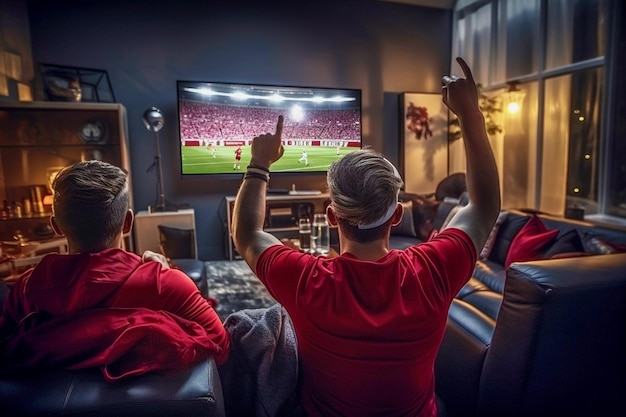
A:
451 0 626 224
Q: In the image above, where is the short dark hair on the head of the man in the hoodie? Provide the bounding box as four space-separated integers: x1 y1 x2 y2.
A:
52 160 130 252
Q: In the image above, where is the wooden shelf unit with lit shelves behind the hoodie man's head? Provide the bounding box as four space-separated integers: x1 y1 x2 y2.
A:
0 101 133 254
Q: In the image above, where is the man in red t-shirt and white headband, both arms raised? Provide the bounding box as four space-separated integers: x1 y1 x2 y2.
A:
233 58 500 417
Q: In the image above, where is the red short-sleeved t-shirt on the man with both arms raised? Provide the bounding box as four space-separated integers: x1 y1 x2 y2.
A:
257 229 476 417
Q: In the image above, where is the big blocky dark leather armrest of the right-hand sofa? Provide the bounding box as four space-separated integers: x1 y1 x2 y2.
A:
478 254 626 416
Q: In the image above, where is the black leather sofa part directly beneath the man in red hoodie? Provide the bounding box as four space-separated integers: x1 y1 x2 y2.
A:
0 358 225 417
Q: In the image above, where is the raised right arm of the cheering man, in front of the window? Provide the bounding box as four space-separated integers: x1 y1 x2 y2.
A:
441 58 500 253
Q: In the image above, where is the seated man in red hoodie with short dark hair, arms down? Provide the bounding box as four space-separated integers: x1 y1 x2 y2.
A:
0 161 230 380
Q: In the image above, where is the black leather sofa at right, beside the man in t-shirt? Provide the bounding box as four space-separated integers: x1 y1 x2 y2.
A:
435 210 626 417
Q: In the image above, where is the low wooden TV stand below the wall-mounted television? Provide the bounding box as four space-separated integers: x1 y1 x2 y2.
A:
224 190 330 261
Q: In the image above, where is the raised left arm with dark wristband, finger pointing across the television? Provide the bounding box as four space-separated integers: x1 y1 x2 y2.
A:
232 116 284 271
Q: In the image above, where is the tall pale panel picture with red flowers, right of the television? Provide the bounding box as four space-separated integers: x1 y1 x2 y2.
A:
399 93 448 194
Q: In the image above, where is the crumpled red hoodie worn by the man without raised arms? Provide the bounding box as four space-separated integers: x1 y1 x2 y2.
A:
0 249 230 380
